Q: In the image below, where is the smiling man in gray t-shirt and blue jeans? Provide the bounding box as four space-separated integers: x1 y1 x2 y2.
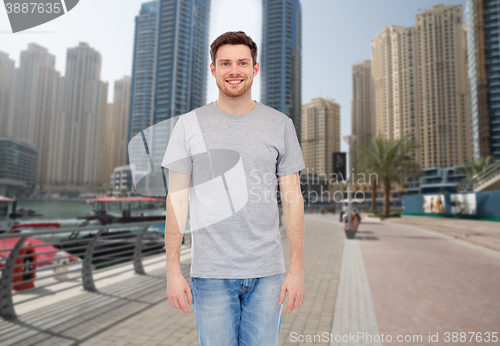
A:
162 31 305 346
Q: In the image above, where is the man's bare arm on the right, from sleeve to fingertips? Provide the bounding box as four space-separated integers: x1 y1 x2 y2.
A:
278 173 306 315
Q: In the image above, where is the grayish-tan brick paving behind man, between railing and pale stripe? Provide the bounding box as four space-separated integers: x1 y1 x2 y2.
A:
0 220 344 346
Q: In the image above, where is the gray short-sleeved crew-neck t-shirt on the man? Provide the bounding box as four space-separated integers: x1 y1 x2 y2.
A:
162 102 305 279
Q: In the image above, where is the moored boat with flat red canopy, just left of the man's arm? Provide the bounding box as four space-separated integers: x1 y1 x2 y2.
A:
77 197 166 227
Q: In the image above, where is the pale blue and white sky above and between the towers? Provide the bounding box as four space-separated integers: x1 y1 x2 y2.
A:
0 0 466 151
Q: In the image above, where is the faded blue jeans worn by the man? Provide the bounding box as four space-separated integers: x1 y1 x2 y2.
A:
191 274 284 346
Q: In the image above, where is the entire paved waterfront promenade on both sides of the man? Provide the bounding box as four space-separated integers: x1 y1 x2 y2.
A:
0 214 500 346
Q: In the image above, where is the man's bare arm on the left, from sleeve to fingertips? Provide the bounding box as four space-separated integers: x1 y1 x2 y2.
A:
165 171 193 315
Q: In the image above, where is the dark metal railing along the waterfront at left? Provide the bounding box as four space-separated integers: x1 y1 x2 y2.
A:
0 221 165 319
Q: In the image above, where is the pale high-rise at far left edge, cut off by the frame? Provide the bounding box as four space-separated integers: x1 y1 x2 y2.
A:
0 52 16 137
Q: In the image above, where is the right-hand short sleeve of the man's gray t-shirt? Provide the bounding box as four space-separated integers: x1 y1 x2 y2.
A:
276 119 306 176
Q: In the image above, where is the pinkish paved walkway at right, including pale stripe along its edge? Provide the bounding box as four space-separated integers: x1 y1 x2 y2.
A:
310 215 500 345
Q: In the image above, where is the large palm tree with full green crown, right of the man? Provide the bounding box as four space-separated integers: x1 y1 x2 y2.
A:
356 136 421 215
